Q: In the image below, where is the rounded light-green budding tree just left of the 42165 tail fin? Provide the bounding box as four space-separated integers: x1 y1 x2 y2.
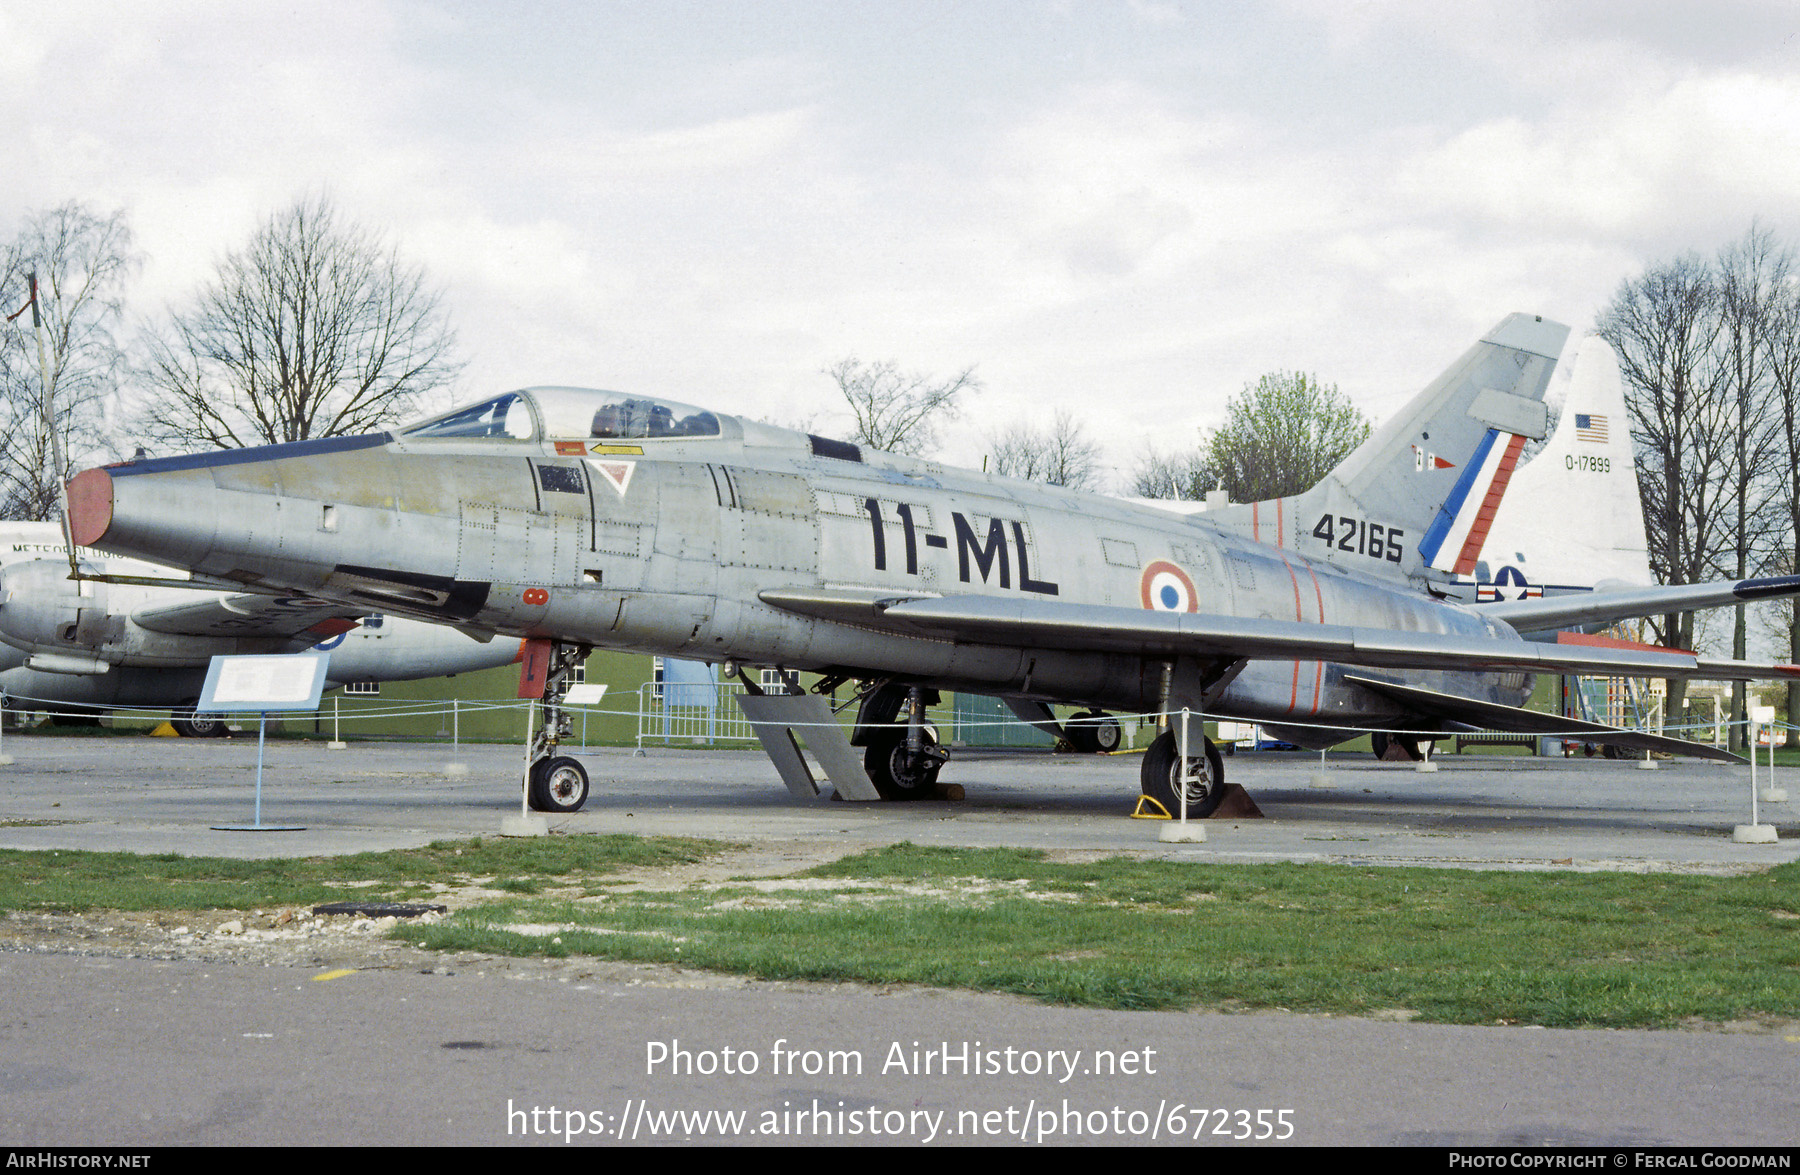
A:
1206 371 1368 502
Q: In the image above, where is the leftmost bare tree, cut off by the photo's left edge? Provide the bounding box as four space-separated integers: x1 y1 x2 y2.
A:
0 202 139 522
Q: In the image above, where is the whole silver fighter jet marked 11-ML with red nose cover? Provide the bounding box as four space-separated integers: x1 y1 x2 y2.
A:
68 315 1800 815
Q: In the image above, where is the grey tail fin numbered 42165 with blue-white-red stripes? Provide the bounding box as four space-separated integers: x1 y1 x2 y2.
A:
1206 315 1568 576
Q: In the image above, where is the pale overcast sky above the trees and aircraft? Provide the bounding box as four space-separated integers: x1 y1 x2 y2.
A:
0 0 1800 470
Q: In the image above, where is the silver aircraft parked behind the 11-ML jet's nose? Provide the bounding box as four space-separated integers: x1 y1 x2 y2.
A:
0 522 520 736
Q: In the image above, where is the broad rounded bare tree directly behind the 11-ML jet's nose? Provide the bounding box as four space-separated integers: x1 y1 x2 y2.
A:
144 198 461 448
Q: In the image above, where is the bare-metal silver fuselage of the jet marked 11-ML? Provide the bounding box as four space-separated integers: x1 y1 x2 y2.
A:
72 390 1530 745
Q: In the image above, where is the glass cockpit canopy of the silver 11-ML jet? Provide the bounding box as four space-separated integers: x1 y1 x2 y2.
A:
400 387 720 441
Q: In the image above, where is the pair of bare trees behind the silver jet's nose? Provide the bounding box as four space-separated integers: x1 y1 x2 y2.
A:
0 196 463 520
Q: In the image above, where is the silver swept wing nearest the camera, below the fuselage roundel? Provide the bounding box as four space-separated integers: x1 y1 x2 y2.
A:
760 579 1800 677
